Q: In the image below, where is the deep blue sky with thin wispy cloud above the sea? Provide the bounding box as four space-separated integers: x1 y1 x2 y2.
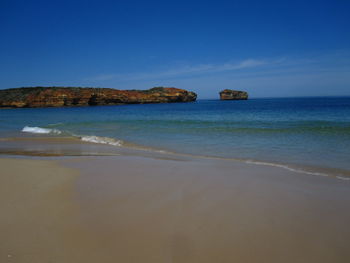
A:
0 0 350 99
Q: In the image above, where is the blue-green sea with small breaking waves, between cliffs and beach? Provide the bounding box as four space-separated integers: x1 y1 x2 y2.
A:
0 97 350 178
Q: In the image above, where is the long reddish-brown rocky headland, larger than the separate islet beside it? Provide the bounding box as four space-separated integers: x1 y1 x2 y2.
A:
0 87 197 108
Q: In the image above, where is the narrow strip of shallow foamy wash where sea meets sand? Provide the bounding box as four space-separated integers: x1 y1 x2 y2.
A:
0 135 350 181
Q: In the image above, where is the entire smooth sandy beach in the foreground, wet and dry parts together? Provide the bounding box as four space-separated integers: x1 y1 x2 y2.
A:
0 156 350 262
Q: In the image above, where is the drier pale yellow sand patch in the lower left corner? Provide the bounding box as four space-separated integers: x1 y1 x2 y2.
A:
0 158 102 263
